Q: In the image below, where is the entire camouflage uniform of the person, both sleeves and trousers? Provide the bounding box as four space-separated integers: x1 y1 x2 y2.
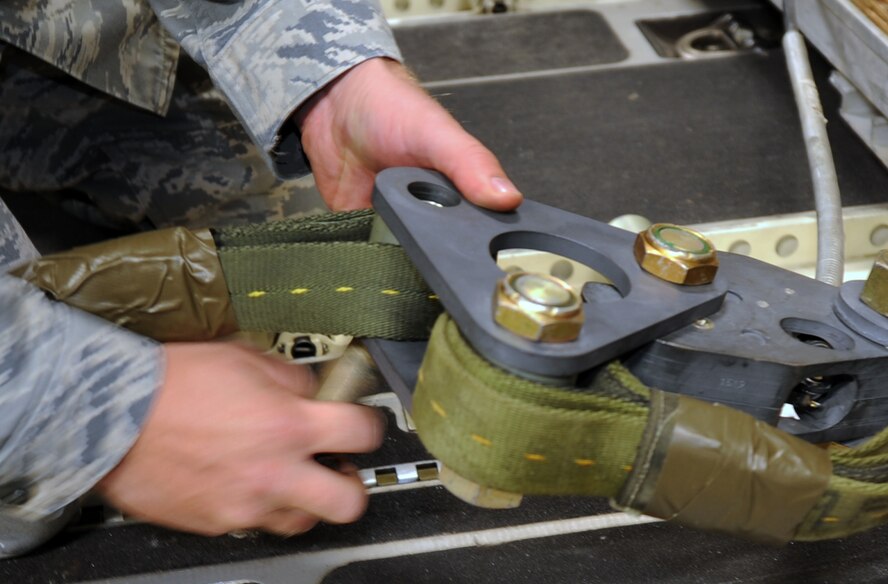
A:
0 0 400 555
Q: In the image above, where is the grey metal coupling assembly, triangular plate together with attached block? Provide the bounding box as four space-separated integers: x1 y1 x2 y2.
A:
371 168 888 441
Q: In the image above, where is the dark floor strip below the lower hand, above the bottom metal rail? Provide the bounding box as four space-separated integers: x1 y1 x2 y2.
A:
0 486 611 584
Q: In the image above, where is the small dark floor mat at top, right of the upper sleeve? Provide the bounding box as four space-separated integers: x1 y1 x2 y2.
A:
395 10 629 81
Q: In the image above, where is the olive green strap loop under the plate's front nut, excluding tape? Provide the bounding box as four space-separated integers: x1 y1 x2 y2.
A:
413 316 648 497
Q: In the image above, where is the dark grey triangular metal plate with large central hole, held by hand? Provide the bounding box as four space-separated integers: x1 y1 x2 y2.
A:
373 168 726 377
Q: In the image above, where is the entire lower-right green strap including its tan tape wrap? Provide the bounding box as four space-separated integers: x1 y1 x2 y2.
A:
413 315 888 541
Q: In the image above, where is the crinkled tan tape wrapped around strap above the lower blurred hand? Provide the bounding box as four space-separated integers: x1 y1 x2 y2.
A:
12 227 237 341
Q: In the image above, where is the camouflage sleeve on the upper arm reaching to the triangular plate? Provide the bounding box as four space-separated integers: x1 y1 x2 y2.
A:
149 0 401 178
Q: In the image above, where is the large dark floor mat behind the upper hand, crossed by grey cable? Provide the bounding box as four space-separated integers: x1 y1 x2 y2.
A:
435 51 888 223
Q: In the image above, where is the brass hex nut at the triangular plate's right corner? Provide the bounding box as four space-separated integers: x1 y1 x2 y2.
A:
635 223 718 286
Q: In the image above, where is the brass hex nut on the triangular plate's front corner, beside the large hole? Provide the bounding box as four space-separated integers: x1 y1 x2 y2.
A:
493 272 583 343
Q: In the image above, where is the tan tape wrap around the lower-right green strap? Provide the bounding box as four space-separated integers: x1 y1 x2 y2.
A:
617 391 832 543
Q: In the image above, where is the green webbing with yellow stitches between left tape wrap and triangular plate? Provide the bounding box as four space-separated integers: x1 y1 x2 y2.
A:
214 211 441 340
